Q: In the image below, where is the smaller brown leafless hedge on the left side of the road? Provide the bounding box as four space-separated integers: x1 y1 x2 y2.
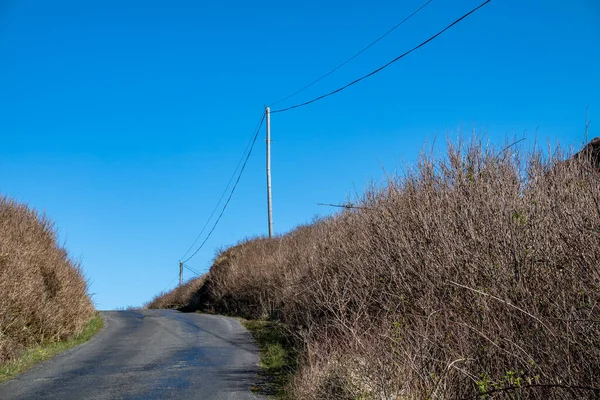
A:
0 196 94 362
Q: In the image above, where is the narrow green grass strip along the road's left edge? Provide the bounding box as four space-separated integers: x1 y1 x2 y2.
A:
0 314 104 382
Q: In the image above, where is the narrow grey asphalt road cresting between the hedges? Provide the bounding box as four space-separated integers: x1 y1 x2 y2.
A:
0 310 260 400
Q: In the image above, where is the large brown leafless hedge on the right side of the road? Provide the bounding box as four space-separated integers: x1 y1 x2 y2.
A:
156 142 600 399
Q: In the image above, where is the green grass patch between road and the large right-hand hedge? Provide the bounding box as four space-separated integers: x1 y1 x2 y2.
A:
242 320 298 400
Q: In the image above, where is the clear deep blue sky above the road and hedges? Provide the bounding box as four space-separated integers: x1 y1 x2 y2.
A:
0 0 600 309
